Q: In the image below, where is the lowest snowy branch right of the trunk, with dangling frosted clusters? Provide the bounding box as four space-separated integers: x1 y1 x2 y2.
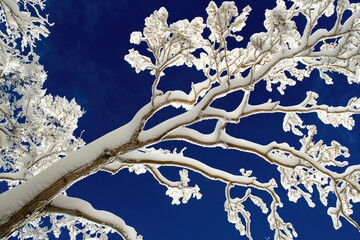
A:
119 149 296 238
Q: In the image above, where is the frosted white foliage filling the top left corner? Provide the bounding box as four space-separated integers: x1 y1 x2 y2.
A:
0 0 49 84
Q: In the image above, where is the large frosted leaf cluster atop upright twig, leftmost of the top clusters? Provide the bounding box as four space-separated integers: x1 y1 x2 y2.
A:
125 5 205 75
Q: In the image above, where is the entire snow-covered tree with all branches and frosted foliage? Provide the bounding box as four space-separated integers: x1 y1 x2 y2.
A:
0 0 360 239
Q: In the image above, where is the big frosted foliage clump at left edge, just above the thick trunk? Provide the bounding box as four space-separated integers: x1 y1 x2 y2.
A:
0 68 83 180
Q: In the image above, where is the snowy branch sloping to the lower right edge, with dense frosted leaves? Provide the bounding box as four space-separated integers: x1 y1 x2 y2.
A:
166 123 360 232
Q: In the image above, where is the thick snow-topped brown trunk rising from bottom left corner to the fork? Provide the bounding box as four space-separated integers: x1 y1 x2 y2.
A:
0 122 145 238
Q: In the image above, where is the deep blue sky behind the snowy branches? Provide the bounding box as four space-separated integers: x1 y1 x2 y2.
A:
38 0 360 240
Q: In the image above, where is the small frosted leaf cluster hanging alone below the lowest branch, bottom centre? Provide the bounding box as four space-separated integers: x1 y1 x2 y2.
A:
166 169 202 205
